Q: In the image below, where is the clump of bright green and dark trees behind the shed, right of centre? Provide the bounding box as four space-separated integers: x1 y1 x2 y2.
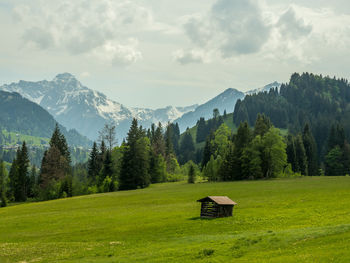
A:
202 115 288 181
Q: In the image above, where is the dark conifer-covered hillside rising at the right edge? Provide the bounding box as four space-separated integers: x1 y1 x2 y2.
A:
233 73 350 160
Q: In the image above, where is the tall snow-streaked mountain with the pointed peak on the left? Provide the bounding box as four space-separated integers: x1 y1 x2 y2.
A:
0 73 197 140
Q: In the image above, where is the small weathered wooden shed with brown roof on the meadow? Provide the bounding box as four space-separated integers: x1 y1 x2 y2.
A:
197 196 237 218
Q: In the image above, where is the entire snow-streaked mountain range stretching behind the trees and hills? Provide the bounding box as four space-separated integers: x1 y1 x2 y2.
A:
0 73 280 141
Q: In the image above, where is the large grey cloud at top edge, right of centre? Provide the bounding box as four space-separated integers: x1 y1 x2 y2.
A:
180 0 270 58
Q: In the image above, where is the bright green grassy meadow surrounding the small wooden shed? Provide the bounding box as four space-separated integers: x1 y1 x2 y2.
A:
0 177 350 263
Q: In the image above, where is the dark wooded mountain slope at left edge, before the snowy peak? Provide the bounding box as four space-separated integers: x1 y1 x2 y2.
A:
0 91 91 147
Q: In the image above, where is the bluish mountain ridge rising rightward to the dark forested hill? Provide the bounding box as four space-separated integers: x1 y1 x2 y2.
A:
175 81 281 132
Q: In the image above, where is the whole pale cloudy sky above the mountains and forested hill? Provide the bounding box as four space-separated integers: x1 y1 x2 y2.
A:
0 0 350 108
